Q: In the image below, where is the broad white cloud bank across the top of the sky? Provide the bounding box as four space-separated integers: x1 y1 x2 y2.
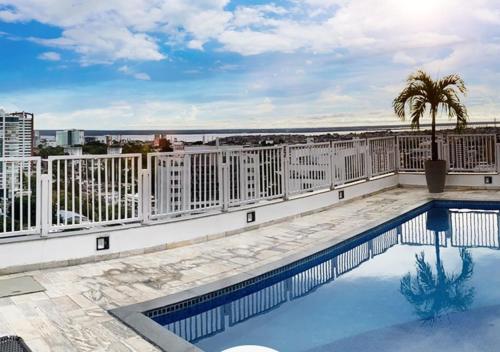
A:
0 0 500 65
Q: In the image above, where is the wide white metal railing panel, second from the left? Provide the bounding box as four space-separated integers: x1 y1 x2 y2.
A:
48 154 142 231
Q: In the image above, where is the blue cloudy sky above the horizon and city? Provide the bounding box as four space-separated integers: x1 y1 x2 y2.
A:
0 0 500 129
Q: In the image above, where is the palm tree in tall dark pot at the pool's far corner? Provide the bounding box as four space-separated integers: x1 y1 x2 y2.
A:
392 70 468 193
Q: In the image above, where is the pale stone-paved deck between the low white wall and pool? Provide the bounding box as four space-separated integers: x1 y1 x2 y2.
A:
0 188 500 352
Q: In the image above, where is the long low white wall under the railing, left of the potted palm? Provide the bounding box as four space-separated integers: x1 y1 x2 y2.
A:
0 175 398 273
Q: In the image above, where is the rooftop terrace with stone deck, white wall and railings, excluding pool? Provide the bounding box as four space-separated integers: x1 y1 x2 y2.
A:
0 135 500 351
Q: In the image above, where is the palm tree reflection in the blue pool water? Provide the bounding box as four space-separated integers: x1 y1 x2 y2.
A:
400 209 474 322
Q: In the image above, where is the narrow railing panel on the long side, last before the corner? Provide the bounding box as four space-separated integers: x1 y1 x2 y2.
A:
368 137 396 176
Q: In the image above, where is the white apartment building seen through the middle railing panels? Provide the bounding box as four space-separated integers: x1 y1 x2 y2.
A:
155 145 280 213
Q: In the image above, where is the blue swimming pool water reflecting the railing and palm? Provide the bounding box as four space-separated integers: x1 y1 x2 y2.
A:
154 202 500 352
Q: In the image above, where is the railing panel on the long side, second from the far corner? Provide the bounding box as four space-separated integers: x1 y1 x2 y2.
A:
332 139 368 185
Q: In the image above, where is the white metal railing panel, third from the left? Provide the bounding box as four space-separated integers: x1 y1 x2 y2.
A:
148 150 222 219
